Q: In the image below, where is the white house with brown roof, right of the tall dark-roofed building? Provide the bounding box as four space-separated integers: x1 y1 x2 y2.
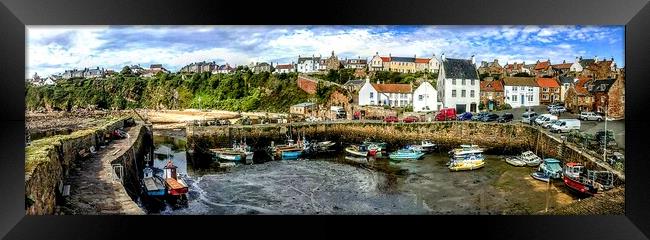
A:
503 77 539 108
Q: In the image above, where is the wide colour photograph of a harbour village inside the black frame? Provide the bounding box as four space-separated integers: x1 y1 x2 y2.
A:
25 25 625 215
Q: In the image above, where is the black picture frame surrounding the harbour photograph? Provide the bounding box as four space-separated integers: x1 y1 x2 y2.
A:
0 0 650 239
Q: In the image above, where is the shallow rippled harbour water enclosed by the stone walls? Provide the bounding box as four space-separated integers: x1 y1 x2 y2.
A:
145 133 576 215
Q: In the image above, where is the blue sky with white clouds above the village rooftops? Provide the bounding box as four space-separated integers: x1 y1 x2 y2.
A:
25 26 625 77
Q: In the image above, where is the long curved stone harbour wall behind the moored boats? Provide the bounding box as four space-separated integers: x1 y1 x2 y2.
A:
187 121 625 181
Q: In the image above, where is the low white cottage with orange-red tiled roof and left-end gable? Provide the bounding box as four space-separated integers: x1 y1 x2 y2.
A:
359 78 413 107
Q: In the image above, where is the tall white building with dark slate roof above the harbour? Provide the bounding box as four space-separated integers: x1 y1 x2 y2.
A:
438 53 481 113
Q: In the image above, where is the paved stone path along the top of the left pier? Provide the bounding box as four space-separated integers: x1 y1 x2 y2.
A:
61 126 144 215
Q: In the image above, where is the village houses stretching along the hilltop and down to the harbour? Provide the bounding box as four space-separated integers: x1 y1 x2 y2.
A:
27 51 625 119
